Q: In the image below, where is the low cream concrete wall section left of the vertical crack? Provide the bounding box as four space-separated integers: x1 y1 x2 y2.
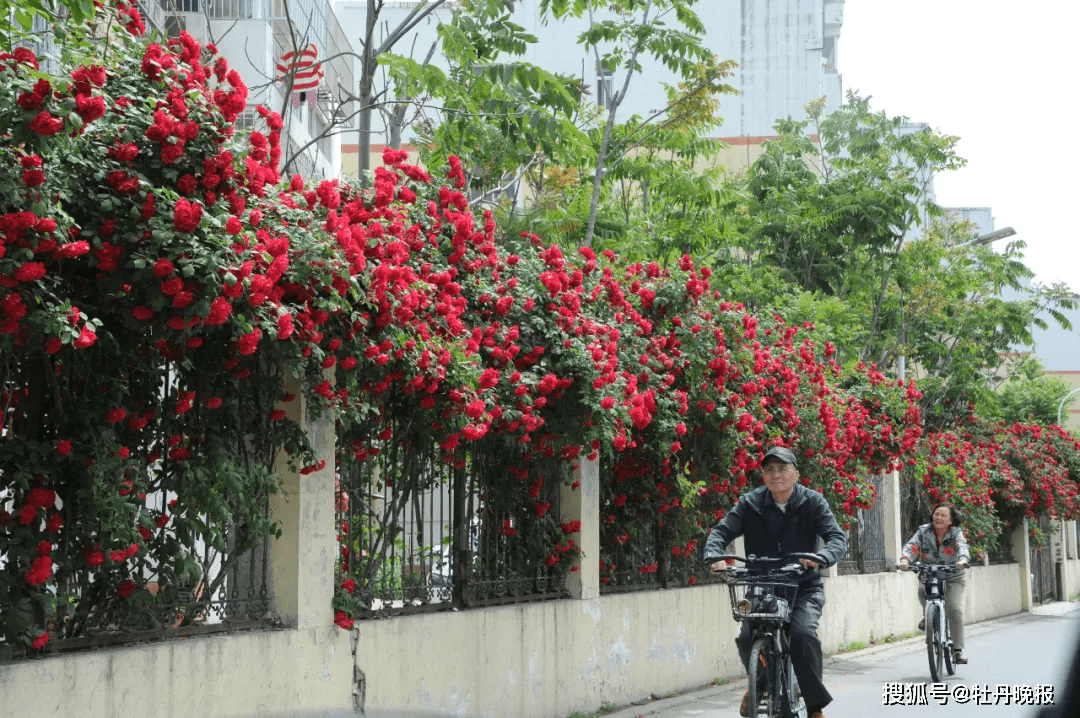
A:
0 626 353 718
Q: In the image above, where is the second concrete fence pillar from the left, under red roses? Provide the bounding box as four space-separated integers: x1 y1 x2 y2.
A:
559 459 600 599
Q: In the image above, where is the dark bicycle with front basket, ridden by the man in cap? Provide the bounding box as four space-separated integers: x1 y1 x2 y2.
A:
717 553 821 718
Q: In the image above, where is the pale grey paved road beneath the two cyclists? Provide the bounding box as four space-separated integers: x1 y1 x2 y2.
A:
605 602 1080 718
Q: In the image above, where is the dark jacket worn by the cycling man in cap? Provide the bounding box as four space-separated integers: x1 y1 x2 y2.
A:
705 484 848 585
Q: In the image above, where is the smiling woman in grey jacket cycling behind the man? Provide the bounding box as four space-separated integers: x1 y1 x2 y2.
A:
897 503 971 663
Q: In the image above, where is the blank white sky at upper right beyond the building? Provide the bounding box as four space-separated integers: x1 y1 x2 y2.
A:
837 0 1080 290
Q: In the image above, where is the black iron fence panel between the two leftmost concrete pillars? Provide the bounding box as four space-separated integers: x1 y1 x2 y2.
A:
337 444 567 618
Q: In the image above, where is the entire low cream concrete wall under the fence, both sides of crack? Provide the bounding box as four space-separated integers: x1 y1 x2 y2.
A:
0 561 1028 718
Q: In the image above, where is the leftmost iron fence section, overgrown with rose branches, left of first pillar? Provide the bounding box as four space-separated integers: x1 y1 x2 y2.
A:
0 365 279 659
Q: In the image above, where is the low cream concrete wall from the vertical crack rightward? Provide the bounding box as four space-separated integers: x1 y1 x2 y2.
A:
356 564 1021 718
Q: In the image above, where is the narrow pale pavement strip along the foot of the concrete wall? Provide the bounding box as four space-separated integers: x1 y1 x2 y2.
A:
603 601 1080 718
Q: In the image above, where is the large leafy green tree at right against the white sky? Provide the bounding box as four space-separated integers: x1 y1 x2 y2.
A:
720 94 1072 425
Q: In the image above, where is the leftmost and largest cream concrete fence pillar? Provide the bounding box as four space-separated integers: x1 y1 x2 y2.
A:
270 376 337 628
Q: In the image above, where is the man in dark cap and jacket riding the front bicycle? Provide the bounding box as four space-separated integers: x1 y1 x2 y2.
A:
705 447 848 718
